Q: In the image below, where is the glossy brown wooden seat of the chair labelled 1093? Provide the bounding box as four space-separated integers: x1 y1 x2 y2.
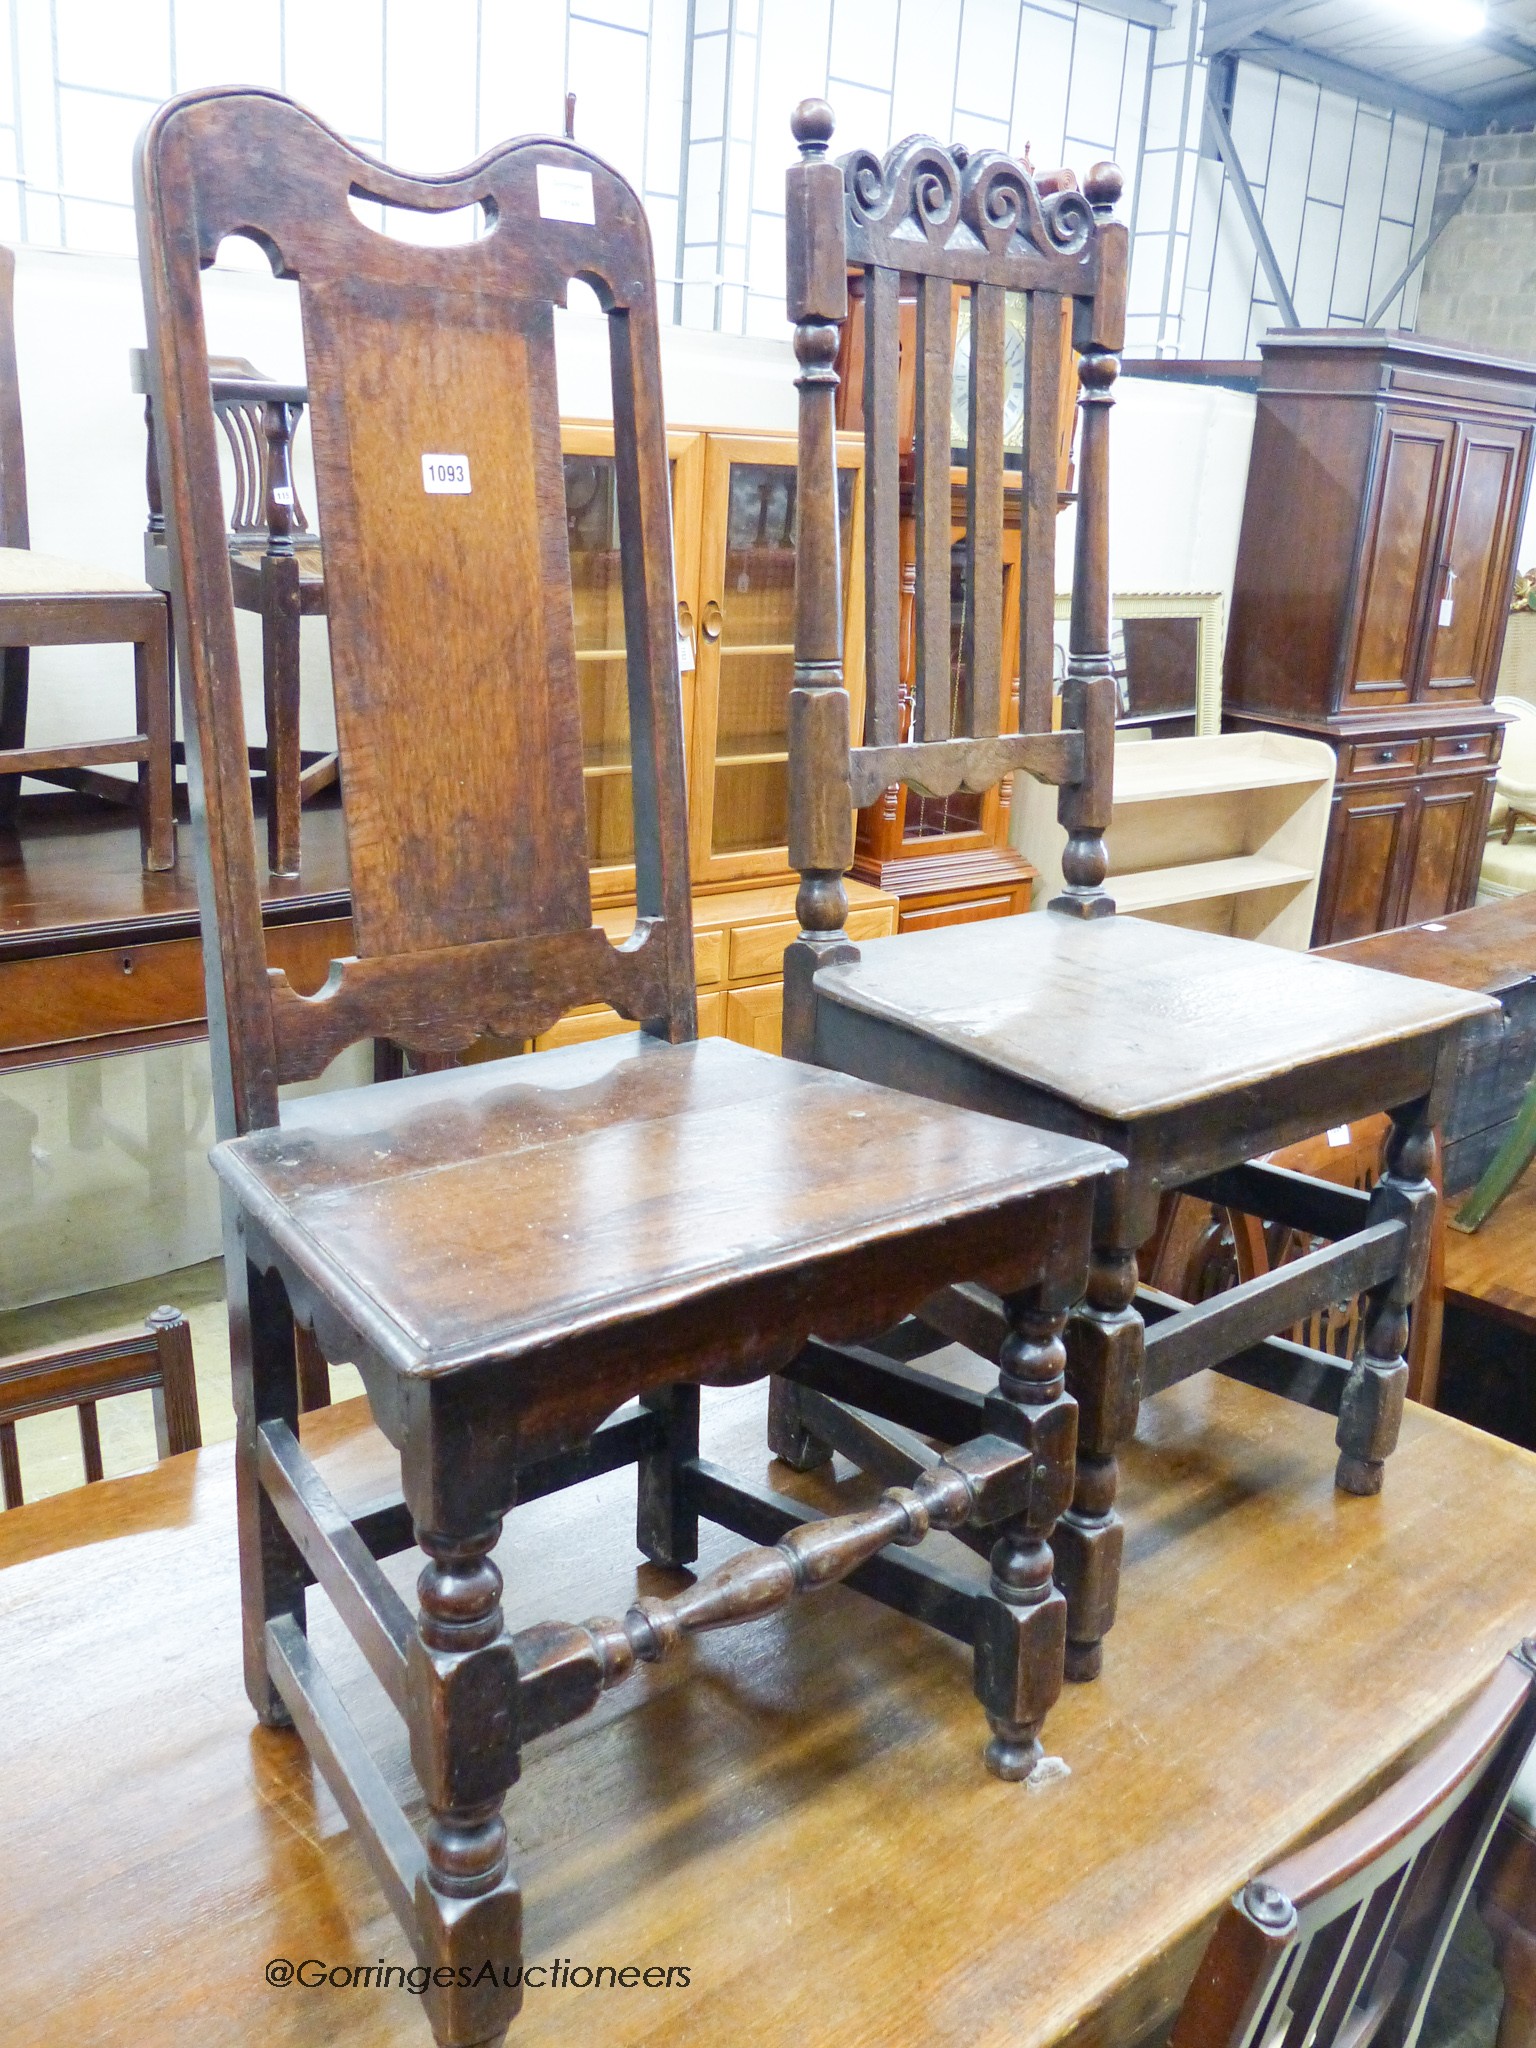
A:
213 1036 1112 1378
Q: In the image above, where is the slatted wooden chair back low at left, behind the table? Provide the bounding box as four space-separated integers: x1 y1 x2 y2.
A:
0 1309 203 1507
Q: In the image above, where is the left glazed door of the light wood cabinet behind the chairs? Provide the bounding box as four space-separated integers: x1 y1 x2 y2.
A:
561 420 705 903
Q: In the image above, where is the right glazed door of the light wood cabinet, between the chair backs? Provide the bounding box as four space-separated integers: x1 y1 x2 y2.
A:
688 434 864 888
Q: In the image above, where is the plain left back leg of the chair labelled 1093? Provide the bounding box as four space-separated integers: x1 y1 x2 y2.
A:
225 1229 307 1729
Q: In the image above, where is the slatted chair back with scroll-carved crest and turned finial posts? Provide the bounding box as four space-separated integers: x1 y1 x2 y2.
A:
784 100 1126 1053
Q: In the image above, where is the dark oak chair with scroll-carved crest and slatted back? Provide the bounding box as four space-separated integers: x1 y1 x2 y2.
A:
770 100 1489 1679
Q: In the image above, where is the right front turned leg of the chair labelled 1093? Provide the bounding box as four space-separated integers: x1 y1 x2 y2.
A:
975 1292 1077 1780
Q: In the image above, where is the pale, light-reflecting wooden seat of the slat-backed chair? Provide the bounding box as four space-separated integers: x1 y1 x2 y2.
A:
815 915 1489 1122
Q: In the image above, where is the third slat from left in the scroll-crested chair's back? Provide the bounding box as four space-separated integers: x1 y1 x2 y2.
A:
961 285 1008 737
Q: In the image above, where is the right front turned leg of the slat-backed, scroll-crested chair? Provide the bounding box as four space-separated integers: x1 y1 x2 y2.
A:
1335 1104 1438 1493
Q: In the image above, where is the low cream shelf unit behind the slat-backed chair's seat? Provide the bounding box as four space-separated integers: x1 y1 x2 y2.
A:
1014 731 1335 950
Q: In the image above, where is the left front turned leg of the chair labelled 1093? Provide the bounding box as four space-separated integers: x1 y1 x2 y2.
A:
410 1518 522 2048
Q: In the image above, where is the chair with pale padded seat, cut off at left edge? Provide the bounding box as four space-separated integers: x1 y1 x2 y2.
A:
0 248 176 870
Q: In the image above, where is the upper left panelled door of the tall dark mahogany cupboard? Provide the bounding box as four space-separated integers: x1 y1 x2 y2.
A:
1339 412 1456 712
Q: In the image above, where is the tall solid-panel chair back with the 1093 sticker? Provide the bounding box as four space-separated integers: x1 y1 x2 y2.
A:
139 88 696 1137
